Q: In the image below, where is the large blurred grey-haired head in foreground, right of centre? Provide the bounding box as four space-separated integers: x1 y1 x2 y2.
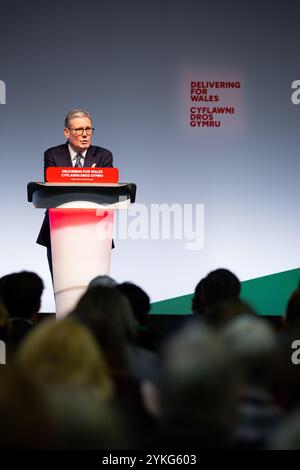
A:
161 326 237 430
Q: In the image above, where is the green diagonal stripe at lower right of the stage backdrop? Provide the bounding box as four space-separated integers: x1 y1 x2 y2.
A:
150 268 300 315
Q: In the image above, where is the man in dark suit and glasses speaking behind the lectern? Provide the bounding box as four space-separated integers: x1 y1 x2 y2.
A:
36 109 113 273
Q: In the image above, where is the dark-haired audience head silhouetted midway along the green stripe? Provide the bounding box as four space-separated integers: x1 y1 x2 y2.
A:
192 269 241 314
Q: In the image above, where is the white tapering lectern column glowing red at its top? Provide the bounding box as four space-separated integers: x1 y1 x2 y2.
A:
49 209 114 317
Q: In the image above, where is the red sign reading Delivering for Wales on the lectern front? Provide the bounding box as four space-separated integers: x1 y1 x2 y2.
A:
46 166 119 183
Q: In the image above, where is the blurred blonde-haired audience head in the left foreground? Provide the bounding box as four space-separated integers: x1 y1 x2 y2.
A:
16 318 113 399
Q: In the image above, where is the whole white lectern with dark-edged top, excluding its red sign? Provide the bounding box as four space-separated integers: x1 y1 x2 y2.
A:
27 182 136 318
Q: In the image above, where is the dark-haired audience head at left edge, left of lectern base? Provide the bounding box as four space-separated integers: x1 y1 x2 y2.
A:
0 271 44 319
